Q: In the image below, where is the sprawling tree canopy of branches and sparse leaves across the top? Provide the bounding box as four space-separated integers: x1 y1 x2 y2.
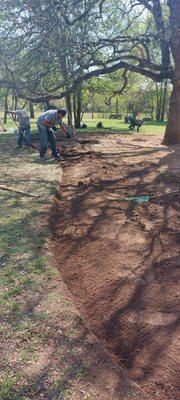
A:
0 0 180 144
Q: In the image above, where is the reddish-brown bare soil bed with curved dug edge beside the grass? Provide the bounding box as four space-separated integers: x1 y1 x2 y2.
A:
51 135 180 400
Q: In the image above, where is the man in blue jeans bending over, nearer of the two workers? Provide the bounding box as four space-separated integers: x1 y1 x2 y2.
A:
37 108 67 160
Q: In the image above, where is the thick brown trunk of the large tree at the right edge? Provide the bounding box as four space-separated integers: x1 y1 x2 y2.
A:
163 0 180 145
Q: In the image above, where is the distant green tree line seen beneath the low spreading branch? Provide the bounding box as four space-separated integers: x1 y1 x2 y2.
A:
0 73 171 128
